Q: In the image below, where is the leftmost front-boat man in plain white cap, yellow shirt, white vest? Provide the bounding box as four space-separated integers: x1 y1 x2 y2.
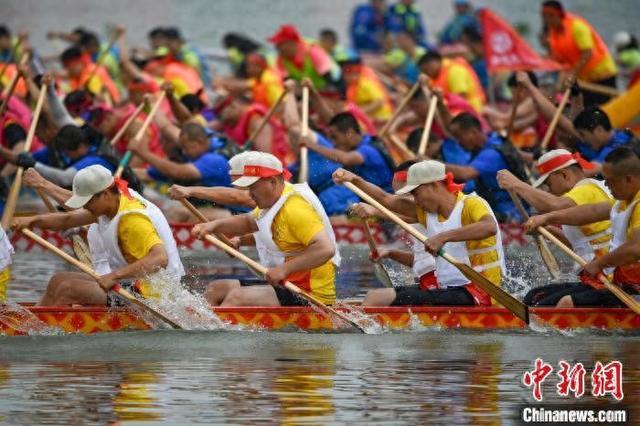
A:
13 165 184 305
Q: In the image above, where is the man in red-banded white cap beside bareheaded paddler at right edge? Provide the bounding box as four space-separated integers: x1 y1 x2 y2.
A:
497 149 615 305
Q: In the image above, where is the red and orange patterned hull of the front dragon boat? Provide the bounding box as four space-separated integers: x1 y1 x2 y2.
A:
0 306 640 335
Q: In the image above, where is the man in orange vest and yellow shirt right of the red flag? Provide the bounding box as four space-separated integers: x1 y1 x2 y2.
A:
541 0 618 106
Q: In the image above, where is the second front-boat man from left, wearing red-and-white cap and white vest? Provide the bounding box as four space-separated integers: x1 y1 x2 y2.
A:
193 153 340 306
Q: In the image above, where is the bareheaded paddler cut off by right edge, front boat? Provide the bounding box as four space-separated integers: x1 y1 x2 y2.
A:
525 147 640 307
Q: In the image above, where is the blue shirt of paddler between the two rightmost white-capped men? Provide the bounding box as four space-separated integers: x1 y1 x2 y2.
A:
469 133 520 218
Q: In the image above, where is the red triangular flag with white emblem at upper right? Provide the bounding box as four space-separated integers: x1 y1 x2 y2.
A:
479 8 563 73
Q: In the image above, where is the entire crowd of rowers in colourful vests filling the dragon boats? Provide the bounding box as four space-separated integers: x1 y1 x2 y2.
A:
0 1 640 312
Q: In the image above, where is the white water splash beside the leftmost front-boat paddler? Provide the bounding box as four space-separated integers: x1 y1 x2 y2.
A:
120 271 227 330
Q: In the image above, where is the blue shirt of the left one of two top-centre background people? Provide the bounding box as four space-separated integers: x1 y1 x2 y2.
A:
350 4 385 53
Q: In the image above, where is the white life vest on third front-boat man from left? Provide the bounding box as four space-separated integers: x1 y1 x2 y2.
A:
426 194 505 305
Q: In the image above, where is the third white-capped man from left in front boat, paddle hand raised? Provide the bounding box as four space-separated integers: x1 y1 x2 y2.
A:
333 160 504 306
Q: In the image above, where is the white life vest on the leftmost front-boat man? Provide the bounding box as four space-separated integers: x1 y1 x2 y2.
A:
87 189 185 278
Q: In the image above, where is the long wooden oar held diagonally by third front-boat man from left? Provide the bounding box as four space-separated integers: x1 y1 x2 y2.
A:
343 182 529 324
